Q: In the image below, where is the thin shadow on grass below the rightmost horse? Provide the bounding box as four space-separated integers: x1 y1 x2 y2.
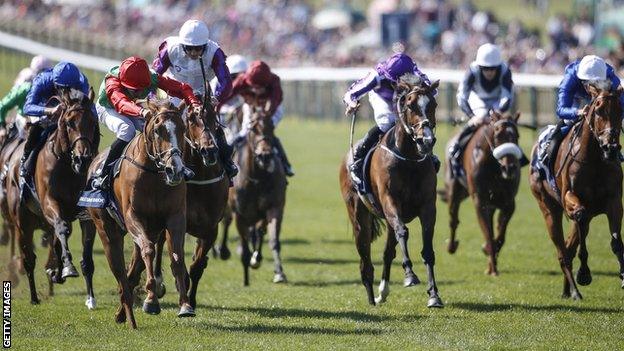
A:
450 302 624 313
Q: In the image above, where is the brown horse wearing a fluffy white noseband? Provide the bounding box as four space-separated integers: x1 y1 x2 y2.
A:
441 112 522 276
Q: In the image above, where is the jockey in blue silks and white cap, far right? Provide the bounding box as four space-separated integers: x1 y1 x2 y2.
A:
542 55 624 168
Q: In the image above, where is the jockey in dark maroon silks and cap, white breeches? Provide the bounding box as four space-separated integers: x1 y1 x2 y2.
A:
223 60 295 177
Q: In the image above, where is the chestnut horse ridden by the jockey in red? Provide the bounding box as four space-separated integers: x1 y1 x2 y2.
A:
88 100 195 328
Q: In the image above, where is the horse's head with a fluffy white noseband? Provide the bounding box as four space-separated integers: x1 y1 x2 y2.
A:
486 111 522 179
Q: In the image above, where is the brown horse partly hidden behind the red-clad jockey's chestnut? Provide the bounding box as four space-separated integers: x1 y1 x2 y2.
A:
154 103 230 308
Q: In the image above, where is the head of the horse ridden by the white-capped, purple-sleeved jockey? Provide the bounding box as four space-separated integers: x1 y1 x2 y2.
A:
185 104 219 166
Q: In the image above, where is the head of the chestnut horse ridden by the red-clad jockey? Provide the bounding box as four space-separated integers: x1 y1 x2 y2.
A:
143 100 185 186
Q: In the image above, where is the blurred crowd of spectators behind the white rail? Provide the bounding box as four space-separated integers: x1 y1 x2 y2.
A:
0 0 624 73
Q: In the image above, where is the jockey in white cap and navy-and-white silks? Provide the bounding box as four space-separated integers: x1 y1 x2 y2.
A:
449 43 516 176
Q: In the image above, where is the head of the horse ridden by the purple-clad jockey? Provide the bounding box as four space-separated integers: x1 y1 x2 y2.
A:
395 74 440 155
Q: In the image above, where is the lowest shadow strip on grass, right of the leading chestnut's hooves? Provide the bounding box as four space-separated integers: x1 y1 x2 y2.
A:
198 323 383 335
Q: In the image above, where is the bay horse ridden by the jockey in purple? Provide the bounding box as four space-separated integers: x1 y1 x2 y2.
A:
340 75 443 307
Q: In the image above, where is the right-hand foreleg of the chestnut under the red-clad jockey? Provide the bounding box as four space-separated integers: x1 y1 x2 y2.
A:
165 212 195 317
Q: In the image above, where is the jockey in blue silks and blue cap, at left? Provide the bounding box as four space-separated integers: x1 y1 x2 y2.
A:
20 61 91 186
